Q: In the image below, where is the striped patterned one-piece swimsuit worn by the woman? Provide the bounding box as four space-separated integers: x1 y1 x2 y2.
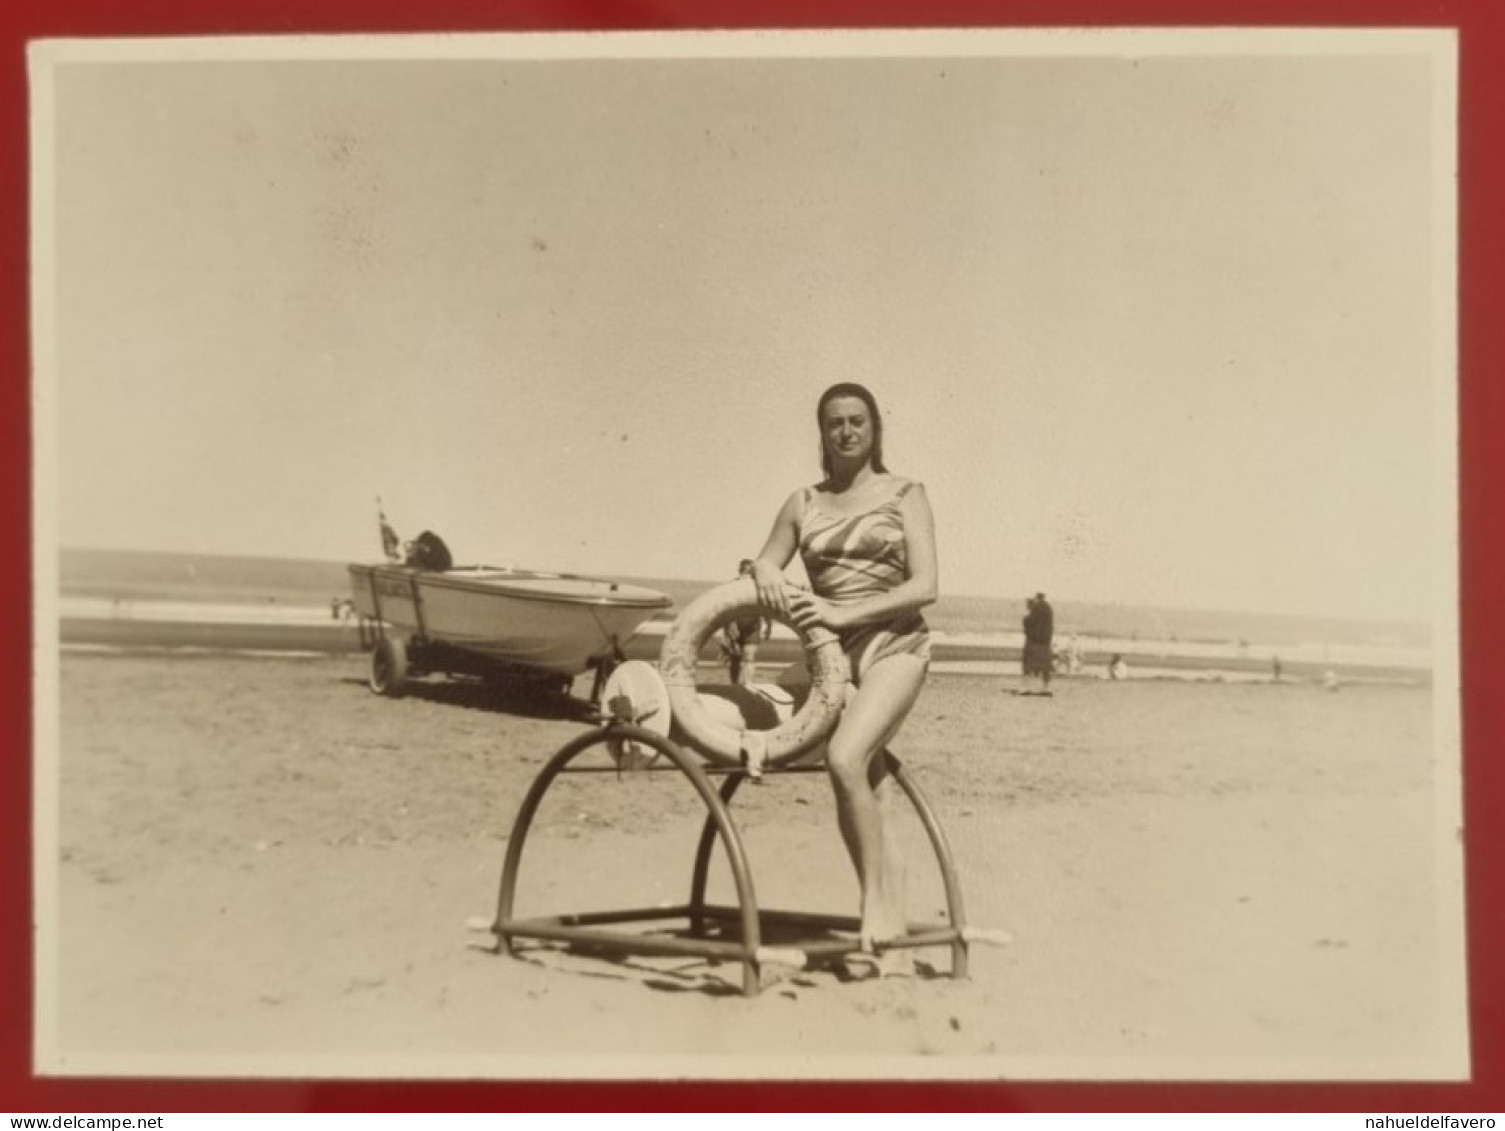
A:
799 479 930 684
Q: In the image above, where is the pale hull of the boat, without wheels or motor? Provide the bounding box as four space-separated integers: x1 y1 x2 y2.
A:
349 565 671 676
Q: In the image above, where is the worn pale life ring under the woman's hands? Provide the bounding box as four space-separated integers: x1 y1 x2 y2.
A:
659 578 850 767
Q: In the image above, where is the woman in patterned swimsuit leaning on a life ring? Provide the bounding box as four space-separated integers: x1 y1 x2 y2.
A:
753 383 938 973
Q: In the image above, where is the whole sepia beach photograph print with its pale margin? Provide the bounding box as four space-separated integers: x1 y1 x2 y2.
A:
29 29 1470 1081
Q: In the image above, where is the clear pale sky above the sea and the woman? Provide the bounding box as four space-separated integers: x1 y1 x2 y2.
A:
38 35 1452 619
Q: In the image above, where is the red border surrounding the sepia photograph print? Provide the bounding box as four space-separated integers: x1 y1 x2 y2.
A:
0 0 1505 1114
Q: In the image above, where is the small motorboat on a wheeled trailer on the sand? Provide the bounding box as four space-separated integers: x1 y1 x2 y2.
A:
349 521 673 696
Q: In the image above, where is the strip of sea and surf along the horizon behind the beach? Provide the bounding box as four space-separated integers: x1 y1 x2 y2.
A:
57 548 1431 676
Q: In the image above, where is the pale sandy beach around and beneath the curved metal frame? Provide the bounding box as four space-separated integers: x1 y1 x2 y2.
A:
39 654 1467 1078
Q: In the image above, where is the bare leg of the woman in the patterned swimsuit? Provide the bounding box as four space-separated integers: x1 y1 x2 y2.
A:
826 655 926 946
